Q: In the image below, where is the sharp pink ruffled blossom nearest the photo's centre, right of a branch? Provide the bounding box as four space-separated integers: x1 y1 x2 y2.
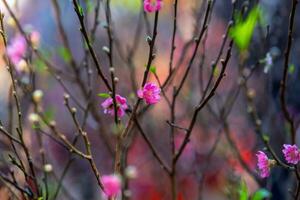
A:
137 83 160 104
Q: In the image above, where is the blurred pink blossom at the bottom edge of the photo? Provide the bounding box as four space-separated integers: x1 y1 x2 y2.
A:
101 174 122 198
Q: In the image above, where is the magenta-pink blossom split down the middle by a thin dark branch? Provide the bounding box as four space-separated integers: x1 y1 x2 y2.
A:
101 94 128 117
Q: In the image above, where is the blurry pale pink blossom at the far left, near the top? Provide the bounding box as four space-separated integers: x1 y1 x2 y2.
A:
7 35 27 65
